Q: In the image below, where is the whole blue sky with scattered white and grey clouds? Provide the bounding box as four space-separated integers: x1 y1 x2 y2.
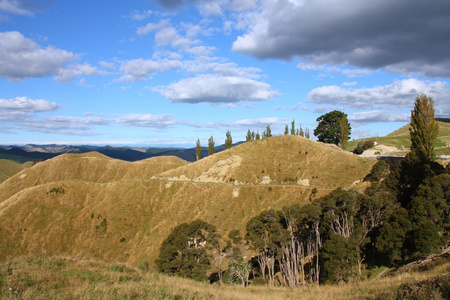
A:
0 0 450 148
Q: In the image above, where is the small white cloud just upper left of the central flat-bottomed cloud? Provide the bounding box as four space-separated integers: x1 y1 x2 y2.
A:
120 58 182 82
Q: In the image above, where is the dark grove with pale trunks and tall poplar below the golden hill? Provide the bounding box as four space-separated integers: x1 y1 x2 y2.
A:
156 95 450 288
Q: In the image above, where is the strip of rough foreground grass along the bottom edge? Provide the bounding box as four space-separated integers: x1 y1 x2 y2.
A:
0 255 450 300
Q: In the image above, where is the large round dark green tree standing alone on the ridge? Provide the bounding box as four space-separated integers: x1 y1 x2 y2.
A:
314 110 351 145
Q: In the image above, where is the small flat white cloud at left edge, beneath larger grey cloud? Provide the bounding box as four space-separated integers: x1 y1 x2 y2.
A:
0 97 58 112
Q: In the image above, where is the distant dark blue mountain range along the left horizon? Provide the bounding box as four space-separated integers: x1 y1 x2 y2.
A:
0 142 242 163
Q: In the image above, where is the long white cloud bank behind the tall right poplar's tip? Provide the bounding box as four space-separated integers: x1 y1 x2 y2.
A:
306 78 450 115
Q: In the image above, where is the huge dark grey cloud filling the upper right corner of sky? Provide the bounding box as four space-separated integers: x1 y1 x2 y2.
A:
232 0 450 77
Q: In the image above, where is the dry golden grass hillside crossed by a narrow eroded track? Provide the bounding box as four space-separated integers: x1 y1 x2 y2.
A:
0 136 376 268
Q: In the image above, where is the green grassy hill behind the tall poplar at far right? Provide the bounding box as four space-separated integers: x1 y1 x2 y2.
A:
347 122 450 153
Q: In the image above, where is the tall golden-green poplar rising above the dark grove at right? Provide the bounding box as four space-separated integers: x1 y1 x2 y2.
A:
409 94 439 161
